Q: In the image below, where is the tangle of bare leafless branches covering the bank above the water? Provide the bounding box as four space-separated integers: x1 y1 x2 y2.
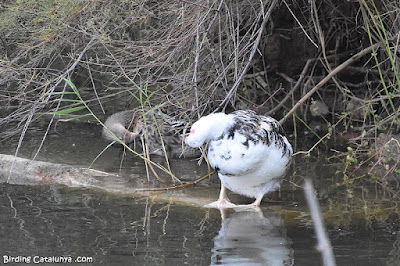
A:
0 0 400 179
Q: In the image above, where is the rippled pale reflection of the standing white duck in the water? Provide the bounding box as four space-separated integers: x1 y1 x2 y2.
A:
211 209 293 265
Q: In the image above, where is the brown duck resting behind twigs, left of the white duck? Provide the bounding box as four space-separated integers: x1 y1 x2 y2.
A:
103 109 200 158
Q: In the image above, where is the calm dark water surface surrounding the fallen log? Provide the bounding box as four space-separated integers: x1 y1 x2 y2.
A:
0 121 400 265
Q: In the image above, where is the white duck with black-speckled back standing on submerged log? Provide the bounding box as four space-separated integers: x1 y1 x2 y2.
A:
186 110 293 208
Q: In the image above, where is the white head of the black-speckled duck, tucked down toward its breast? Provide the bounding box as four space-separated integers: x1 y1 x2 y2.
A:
185 113 234 148
